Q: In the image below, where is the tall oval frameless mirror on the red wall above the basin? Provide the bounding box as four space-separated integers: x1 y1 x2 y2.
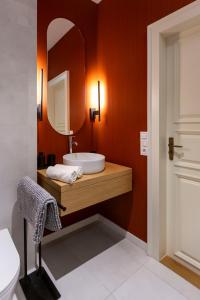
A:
47 18 85 135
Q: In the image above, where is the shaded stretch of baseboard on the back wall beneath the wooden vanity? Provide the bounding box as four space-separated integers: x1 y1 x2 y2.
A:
42 214 99 245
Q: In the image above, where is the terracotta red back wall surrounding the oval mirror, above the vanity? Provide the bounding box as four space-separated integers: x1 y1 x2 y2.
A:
37 0 97 162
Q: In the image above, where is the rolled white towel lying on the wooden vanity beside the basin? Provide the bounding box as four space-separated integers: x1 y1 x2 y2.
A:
46 165 83 184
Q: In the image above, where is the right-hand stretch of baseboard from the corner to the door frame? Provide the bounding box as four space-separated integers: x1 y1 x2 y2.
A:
99 215 147 251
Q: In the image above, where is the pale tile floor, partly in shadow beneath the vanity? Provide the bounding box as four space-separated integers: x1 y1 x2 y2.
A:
18 223 200 300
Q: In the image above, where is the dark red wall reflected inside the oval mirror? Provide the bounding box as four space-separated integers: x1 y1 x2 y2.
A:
48 26 86 132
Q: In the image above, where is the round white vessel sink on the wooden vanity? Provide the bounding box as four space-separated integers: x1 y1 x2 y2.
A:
63 152 105 174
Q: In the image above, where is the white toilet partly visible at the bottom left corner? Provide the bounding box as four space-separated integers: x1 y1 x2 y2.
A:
0 229 20 300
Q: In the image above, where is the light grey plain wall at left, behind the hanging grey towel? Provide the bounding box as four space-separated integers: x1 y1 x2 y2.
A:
0 0 37 270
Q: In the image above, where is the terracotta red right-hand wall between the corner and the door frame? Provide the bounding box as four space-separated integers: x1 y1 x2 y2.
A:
95 0 195 241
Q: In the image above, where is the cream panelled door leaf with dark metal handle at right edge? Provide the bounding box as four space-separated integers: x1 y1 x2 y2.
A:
166 26 200 269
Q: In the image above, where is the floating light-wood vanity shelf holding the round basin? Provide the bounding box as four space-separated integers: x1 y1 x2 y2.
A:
37 162 132 217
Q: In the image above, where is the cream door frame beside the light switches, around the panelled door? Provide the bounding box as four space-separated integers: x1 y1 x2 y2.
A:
147 0 200 260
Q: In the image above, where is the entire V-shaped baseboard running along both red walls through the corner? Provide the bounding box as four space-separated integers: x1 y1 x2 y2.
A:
42 214 147 251
